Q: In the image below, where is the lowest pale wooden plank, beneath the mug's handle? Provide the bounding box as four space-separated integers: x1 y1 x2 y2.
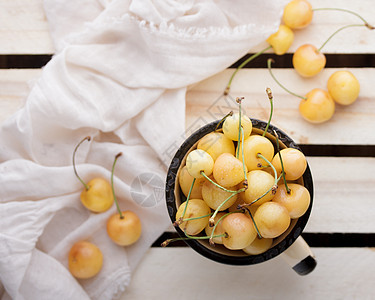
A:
120 248 375 300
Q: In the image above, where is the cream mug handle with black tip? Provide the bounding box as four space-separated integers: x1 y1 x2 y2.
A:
280 236 317 275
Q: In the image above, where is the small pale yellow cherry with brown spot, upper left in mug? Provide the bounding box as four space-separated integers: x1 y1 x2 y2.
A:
186 149 214 178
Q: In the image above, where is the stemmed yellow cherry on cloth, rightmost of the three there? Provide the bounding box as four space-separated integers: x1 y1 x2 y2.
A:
107 211 142 246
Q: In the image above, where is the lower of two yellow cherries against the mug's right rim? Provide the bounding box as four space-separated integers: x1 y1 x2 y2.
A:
272 183 310 219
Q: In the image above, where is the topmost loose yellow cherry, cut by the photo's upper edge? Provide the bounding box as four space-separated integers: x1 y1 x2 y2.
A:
282 0 313 29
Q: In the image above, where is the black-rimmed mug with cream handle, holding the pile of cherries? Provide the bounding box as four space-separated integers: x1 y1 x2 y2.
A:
166 119 316 275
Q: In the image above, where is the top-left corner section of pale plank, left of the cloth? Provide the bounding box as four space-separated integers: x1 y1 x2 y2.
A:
0 0 54 54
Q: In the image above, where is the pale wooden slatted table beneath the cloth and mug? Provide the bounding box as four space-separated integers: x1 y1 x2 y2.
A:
0 0 375 300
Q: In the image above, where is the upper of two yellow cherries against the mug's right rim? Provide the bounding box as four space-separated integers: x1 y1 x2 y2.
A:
271 148 307 180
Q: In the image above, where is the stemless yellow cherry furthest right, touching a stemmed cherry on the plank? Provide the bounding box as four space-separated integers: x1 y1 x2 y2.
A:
327 70 360 105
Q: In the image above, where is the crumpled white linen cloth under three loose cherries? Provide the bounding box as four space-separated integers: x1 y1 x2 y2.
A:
0 0 285 300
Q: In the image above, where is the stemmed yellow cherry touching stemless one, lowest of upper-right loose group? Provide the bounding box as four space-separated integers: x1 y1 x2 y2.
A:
299 89 335 123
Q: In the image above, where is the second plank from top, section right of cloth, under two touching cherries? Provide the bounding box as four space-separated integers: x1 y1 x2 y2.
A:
186 68 375 145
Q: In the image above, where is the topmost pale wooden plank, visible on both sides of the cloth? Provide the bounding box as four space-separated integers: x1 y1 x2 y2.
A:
0 0 375 54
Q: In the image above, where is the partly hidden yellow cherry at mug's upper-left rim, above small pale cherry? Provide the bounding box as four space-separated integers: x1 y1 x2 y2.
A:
197 132 234 161
